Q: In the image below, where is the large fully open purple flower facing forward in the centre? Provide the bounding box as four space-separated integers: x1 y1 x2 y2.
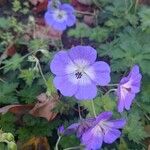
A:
50 46 110 100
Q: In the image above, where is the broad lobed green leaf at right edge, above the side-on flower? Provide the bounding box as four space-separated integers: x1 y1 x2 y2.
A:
100 28 150 74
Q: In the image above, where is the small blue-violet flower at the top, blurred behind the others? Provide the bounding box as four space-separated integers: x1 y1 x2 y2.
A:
45 2 76 31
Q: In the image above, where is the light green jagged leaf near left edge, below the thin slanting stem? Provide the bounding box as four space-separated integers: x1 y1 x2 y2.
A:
3 54 23 73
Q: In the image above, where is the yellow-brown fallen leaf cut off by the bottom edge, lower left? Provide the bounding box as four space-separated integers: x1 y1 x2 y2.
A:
19 137 50 150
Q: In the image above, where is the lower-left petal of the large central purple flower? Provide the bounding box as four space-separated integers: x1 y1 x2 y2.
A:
54 75 78 96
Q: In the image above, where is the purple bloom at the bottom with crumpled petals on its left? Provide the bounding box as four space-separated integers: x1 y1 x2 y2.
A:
67 112 126 150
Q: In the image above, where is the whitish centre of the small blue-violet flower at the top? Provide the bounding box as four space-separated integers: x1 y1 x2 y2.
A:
53 9 67 22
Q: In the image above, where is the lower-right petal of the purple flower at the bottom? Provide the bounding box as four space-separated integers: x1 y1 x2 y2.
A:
104 129 121 143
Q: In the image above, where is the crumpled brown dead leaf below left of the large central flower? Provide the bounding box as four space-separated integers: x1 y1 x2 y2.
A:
29 93 59 121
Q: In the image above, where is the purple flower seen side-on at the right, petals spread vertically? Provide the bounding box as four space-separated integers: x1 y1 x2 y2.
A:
117 65 142 112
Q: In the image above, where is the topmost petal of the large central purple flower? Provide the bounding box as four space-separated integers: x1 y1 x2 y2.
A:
68 46 97 65
